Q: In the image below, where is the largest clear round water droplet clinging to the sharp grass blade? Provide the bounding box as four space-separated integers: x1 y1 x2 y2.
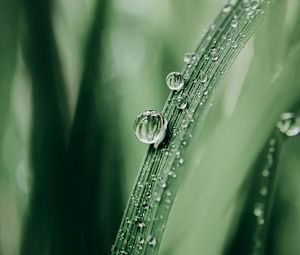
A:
133 110 168 147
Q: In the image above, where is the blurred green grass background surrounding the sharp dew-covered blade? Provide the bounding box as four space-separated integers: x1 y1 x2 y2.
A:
0 0 300 255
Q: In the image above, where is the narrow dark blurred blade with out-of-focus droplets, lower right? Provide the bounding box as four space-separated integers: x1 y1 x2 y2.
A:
226 128 283 255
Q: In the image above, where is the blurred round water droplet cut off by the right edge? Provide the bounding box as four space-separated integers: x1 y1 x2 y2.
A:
277 112 300 136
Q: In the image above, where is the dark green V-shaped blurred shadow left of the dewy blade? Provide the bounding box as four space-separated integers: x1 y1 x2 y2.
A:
21 0 123 255
